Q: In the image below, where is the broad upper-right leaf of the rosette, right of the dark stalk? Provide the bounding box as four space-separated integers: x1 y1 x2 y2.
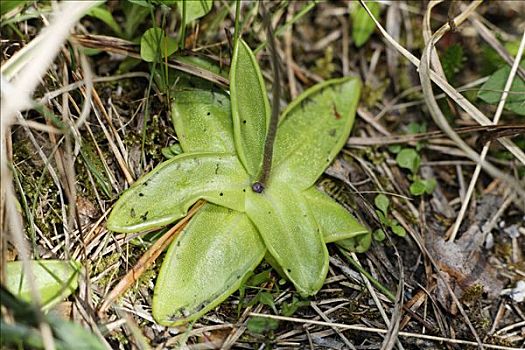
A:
270 78 361 189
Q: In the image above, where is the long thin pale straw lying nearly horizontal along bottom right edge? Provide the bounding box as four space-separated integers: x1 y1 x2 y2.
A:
250 312 520 350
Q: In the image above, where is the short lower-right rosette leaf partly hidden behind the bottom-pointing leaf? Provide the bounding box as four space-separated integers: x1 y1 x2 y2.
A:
302 187 370 247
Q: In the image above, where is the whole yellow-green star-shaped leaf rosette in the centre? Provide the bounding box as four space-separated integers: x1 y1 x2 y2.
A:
108 39 371 326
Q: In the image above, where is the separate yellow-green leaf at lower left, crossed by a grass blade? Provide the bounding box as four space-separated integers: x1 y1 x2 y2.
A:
6 260 81 309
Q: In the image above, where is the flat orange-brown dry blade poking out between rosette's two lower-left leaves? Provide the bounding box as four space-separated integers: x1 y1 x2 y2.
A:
98 200 206 315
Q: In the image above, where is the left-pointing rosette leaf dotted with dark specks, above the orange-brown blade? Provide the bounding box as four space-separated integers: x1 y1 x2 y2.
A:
107 153 249 232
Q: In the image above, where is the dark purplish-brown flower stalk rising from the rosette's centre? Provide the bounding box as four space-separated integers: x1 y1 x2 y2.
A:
252 2 281 193
